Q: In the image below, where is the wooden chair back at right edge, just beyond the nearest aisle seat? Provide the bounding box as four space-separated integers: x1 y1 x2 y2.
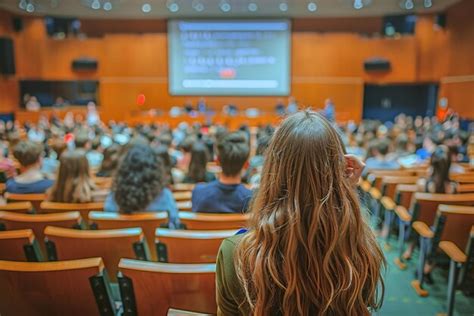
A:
412 192 474 227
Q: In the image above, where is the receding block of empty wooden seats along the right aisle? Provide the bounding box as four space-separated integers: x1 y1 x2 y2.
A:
360 170 474 315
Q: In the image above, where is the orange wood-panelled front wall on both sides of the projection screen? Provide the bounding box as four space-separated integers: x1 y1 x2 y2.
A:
0 0 474 120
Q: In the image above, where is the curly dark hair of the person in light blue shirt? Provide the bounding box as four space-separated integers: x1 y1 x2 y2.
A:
112 144 165 213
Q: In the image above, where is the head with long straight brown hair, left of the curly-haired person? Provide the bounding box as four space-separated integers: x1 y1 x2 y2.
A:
50 150 94 203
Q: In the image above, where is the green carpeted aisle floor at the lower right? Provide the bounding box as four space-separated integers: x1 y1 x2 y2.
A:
376 241 474 316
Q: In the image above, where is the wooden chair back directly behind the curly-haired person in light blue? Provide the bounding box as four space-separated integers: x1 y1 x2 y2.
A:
89 212 168 261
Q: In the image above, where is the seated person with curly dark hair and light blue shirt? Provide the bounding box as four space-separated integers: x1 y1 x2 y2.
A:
104 144 179 228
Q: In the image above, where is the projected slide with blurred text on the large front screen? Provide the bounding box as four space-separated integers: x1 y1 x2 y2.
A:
168 20 290 96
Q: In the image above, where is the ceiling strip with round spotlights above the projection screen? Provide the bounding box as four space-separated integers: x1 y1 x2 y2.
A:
0 0 462 19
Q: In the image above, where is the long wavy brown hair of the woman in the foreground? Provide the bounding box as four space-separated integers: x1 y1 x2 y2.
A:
235 110 385 316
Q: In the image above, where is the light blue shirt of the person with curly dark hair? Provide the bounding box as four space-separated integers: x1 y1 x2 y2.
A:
104 188 179 228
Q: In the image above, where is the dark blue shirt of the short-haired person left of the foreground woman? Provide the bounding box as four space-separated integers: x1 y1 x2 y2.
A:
191 180 252 213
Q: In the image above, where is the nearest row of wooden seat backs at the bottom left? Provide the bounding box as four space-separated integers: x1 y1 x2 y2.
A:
0 257 217 316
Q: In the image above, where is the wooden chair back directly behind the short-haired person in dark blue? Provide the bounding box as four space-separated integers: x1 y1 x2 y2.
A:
179 212 249 230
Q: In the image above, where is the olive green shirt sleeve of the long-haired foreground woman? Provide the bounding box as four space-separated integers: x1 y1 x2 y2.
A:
216 234 250 316
